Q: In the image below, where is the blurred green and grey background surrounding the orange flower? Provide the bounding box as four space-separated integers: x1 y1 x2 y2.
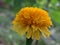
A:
0 0 60 45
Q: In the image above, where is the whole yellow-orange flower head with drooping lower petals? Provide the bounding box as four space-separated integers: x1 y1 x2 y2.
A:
13 7 52 40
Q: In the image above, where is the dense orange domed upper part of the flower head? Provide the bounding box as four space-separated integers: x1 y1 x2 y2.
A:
13 7 52 27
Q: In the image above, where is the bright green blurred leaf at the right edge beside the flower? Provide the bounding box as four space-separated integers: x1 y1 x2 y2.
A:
50 9 60 25
